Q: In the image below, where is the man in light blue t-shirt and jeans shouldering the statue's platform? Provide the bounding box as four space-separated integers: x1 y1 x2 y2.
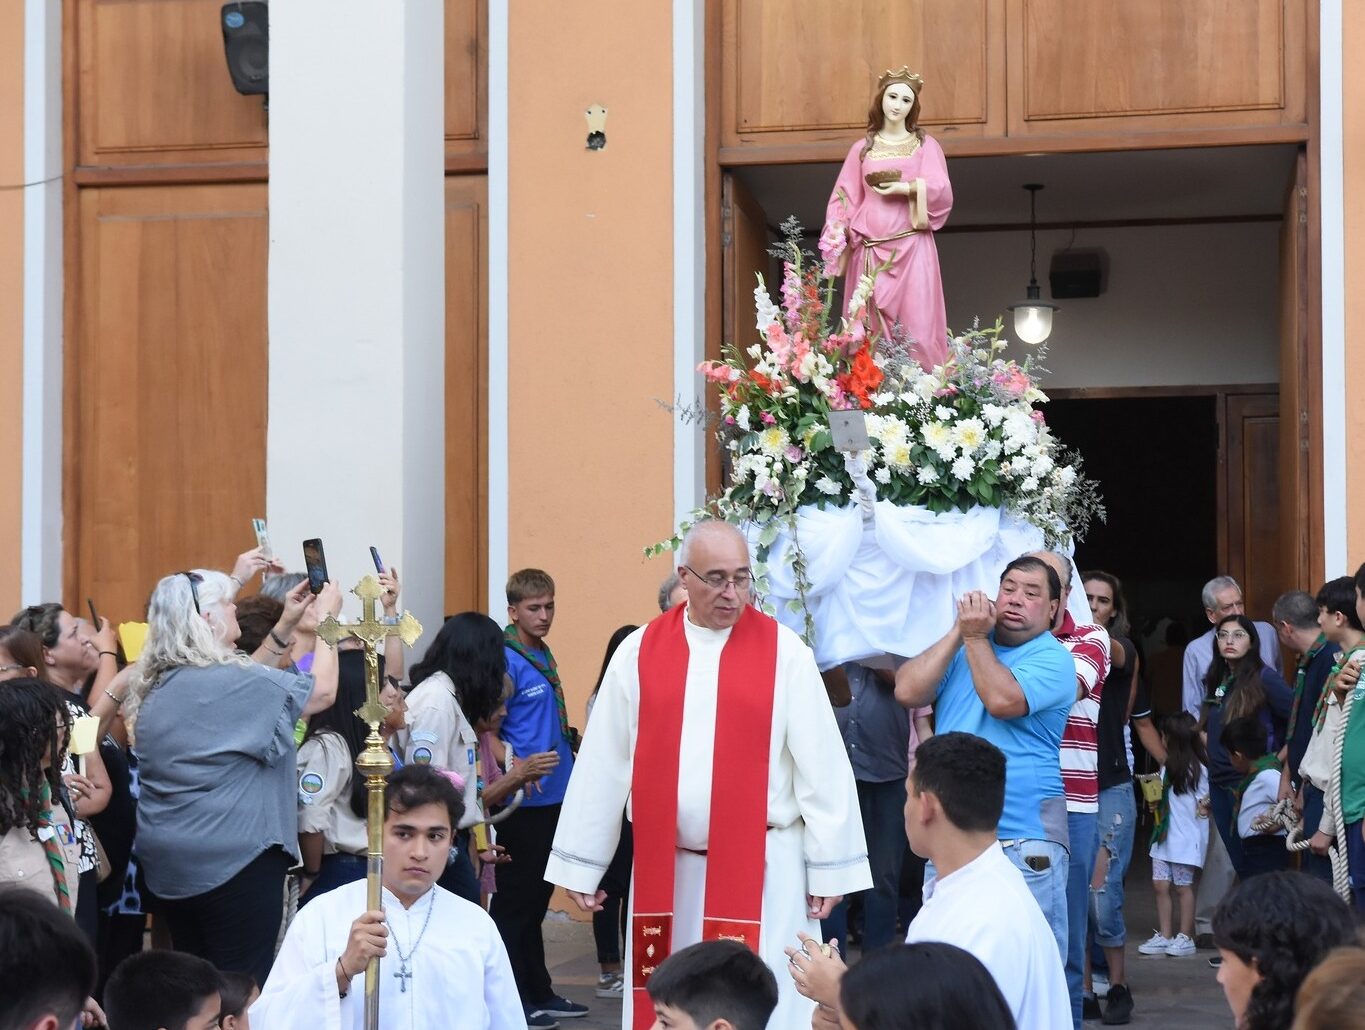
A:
895 555 1076 958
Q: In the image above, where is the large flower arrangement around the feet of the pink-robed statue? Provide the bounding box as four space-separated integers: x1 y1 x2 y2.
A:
687 225 1103 546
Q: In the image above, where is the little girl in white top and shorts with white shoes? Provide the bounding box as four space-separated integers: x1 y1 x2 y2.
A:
1137 712 1208 958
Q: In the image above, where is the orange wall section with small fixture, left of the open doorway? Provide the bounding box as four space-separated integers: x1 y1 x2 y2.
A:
507 0 673 726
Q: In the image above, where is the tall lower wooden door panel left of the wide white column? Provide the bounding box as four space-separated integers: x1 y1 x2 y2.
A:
66 184 268 619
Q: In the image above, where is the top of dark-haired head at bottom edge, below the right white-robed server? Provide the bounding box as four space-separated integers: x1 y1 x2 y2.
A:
839 941 1016 1030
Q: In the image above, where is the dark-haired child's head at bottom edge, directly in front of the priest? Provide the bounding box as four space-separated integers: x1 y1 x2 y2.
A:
648 940 777 1030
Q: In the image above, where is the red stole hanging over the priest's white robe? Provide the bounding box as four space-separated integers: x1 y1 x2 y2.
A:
631 604 777 1030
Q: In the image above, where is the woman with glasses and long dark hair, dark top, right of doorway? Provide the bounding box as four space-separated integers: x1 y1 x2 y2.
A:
1200 615 1294 870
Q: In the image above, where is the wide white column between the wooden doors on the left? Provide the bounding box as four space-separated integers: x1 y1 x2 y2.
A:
266 0 445 627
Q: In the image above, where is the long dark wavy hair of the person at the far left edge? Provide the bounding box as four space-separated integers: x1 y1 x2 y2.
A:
0 677 71 840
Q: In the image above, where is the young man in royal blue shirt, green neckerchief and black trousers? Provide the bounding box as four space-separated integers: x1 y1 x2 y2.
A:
489 569 588 1030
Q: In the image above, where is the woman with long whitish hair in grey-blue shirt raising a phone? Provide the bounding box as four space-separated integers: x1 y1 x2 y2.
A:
124 569 341 984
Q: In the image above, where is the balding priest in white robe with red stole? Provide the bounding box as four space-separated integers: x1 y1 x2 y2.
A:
545 521 872 1030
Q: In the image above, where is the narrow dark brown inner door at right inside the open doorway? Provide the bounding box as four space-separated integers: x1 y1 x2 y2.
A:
1223 393 1287 618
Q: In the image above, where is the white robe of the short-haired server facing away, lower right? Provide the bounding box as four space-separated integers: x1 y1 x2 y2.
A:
905 843 1072 1030
